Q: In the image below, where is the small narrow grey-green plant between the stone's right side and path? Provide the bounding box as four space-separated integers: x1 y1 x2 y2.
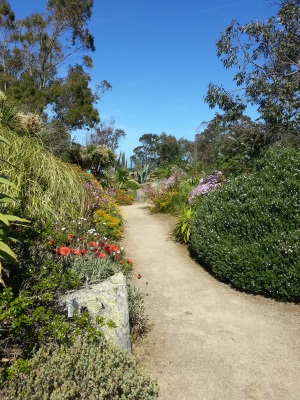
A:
127 284 147 337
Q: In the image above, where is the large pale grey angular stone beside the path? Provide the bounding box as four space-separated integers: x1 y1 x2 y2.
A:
62 272 131 352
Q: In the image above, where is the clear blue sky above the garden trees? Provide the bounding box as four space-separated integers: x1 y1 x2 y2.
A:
8 0 276 158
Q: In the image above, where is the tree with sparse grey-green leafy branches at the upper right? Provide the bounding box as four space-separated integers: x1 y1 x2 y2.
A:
205 0 300 141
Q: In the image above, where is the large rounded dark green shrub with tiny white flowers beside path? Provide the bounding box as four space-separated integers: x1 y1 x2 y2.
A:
190 148 300 302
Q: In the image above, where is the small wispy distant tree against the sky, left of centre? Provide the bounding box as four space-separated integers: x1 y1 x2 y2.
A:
88 119 126 151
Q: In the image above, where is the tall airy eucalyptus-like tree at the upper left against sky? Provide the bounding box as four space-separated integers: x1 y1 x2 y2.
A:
0 0 103 129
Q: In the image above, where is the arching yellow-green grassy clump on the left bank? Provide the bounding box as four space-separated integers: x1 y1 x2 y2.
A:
1 131 85 223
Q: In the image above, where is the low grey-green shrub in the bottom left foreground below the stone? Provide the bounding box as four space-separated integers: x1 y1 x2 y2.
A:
0 339 158 400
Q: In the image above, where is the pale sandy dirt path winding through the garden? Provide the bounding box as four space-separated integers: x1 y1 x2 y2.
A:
123 204 300 400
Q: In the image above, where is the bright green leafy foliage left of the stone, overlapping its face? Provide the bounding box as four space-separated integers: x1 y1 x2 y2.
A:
0 284 105 360
